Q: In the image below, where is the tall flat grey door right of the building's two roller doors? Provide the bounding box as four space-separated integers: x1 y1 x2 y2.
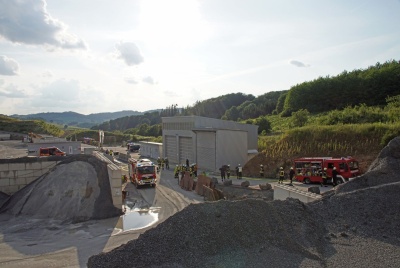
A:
197 132 216 171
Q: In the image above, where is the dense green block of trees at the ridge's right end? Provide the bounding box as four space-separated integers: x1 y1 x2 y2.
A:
278 61 400 116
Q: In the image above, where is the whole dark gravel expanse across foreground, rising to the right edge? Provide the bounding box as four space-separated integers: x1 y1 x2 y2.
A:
88 137 400 267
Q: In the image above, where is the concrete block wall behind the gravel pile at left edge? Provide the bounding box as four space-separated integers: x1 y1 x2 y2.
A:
0 156 62 195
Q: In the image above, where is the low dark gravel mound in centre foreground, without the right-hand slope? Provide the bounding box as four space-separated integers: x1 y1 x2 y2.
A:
88 200 327 267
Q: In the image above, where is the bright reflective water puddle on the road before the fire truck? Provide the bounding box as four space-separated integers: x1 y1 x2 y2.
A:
122 207 160 231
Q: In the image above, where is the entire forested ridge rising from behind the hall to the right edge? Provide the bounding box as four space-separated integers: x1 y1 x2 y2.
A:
93 60 400 131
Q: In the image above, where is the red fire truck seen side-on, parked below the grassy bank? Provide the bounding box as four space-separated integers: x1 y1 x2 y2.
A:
294 156 360 184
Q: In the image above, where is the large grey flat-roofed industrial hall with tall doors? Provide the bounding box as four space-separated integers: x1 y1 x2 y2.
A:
162 116 258 171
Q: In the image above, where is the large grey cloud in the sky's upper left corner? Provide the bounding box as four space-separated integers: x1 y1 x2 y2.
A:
0 0 86 49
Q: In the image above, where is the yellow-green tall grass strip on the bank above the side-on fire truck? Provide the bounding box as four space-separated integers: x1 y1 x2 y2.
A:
258 123 400 158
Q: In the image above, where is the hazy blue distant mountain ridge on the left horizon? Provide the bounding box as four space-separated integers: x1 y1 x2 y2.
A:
10 110 143 128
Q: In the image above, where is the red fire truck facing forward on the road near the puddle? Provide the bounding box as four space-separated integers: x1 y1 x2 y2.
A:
128 158 157 188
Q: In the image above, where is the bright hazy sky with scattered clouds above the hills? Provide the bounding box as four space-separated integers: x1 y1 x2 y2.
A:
0 0 400 115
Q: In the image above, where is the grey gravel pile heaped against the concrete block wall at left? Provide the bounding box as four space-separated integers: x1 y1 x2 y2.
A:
0 155 120 222
